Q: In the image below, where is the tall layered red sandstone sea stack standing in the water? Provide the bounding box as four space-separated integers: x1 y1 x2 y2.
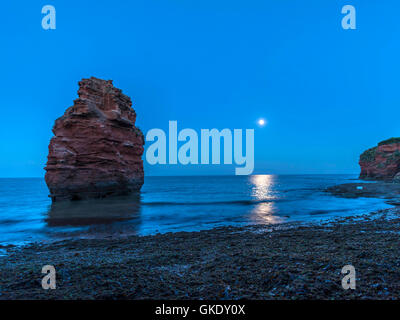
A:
45 77 144 202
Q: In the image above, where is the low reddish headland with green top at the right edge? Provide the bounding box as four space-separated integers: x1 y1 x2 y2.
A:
359 138 400 180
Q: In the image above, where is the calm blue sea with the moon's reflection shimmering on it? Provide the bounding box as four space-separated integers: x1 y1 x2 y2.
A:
0 175 390 245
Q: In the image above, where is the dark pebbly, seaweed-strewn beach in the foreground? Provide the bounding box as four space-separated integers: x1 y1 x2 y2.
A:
0 209 400 299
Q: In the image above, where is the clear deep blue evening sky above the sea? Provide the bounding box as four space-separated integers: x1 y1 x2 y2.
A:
0 0 400 177
